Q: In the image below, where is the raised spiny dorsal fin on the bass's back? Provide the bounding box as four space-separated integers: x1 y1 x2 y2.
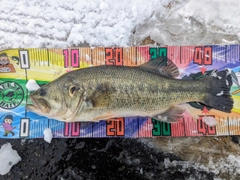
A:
138 56 179 78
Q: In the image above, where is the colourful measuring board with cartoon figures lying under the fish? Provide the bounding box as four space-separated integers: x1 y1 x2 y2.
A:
0 45 240 138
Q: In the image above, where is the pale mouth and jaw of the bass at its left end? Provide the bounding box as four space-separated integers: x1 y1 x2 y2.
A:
26 96 51 113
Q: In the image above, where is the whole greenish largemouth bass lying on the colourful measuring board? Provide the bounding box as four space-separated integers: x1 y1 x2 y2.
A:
27 57 233 122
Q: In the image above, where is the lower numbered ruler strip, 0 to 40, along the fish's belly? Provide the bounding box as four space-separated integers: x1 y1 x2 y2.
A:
20 116 240 138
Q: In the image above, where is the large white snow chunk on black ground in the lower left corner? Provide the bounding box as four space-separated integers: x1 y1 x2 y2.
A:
0 143 22 175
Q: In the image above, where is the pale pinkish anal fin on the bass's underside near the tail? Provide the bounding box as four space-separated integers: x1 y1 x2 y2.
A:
152 105 185 123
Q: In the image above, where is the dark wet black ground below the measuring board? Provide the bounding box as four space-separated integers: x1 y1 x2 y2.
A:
0 138 214 180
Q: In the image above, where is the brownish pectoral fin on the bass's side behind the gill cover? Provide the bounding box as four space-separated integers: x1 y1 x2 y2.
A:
86 83 116 108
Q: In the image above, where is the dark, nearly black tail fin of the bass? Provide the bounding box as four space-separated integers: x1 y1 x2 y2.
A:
204 70 233 113
